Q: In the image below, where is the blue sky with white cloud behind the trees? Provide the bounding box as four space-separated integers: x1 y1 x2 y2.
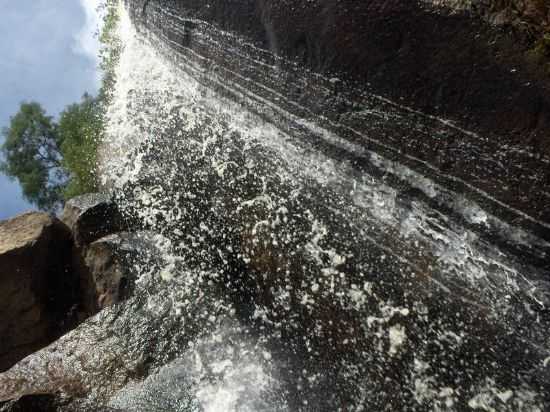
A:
0 0 99 219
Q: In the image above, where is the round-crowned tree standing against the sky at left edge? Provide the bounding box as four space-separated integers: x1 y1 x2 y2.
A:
0 102 67 211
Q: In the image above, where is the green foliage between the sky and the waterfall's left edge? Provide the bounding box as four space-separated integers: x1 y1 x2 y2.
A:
0 0 122 212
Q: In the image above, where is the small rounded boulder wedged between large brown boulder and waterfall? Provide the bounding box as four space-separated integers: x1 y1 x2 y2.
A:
61 193 123 246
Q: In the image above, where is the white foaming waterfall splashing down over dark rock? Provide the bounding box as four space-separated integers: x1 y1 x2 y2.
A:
2 1 550 412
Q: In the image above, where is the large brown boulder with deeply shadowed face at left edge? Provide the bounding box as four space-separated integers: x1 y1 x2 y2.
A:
0 213 78 371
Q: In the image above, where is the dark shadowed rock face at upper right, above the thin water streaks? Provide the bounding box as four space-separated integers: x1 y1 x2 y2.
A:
132 0 550 153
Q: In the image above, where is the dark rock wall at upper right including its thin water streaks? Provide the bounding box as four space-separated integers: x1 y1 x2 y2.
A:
133 0 550 236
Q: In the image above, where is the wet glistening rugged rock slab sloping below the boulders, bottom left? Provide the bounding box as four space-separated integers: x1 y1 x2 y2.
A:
0 233 235 411
